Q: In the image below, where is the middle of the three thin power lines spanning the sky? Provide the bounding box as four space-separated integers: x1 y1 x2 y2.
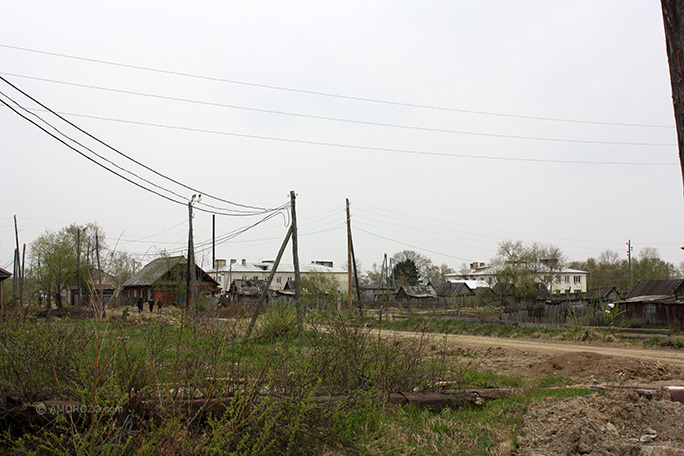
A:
2 72 676 147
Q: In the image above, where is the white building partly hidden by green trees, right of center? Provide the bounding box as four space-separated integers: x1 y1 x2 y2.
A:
444 263 589 294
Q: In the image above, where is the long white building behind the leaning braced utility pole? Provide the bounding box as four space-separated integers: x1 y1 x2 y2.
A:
207 259 348 291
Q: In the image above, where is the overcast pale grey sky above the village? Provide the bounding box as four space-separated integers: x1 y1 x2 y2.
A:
0 0 684 271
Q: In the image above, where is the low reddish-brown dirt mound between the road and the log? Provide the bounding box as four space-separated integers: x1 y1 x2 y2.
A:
529 352 676 383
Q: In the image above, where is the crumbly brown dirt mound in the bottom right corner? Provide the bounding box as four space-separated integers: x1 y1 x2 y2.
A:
516 391 684 456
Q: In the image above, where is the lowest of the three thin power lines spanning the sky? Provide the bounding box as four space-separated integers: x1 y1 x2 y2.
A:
8 106 679 166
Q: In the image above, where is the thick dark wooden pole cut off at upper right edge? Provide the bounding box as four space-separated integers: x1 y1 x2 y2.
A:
661 0 684 192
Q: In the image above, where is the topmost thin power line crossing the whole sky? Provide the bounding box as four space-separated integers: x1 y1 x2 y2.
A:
0 44 674 129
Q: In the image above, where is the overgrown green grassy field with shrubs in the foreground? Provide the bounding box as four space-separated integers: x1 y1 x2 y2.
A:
0 307 588 455
